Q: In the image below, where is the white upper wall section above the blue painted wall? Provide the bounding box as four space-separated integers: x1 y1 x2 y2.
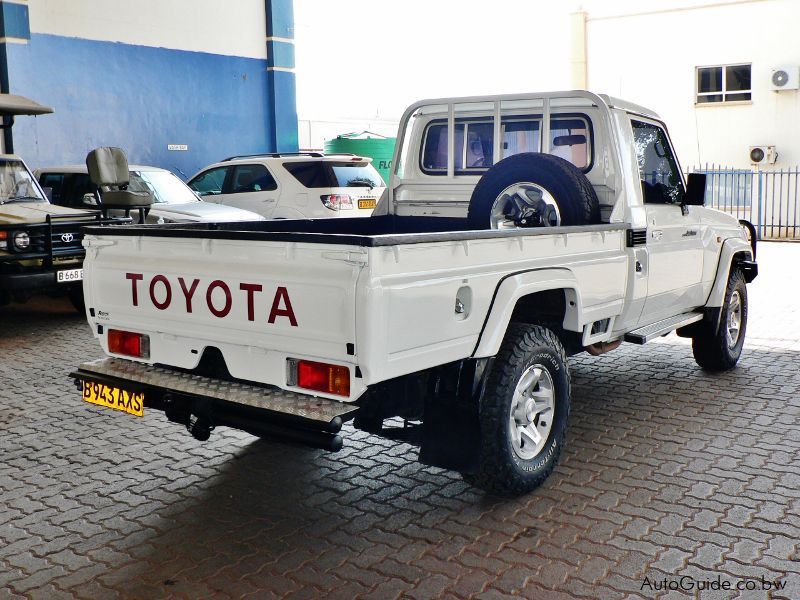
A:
28 0 267 58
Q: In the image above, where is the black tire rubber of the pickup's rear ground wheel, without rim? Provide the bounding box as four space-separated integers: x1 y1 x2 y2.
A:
462 323 570 496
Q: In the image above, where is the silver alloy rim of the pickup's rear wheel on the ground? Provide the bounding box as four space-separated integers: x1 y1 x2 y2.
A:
508 364 555 460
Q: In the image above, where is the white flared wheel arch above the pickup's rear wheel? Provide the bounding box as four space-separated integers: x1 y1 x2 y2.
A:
473 268 582 358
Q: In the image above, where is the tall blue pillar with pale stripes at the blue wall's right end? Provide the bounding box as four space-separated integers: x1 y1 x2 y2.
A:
265 0 298 152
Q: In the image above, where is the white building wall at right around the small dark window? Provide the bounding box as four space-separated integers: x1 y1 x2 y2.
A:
584 0 800 168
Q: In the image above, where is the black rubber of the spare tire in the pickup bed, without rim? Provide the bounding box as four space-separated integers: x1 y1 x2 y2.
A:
467 152 600 229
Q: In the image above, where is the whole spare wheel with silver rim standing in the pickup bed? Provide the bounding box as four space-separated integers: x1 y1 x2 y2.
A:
467 152 600 229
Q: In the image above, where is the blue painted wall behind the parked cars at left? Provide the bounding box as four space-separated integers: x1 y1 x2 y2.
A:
5 33 286 177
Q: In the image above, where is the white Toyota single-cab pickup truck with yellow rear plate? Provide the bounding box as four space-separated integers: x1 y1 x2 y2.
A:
72 91 757 494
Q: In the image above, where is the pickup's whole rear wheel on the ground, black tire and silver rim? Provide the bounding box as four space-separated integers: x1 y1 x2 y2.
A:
463 324 570 496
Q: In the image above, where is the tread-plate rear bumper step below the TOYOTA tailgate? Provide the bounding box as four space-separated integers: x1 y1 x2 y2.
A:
70 358 358 451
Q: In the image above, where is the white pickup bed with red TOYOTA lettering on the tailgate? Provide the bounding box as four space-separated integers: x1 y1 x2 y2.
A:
84 216 628 401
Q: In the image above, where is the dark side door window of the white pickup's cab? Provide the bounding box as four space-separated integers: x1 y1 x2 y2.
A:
631 120 684 204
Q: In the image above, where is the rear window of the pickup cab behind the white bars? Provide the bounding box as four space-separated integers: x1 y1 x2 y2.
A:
420 114 592 175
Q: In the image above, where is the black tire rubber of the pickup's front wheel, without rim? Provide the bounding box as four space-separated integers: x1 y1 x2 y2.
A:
692 268 747 371
